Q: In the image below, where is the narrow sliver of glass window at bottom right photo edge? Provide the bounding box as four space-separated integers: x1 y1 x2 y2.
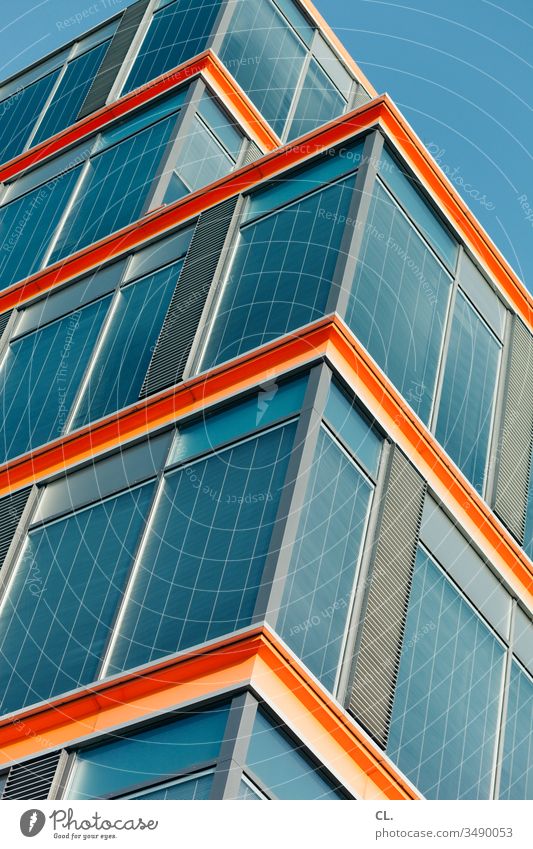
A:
499 661 533 799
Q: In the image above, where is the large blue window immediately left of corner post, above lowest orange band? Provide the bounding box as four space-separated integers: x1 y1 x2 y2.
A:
107 424 295 671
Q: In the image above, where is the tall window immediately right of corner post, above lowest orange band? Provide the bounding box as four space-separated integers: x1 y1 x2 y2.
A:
276 430 372 691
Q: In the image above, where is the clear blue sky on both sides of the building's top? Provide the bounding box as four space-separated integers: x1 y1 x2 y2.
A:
0 0 533 291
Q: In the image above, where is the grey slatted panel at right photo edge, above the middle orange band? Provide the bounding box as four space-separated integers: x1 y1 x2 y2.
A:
494 316 533 542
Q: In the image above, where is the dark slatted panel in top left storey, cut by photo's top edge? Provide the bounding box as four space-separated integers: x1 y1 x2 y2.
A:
78 0 150 120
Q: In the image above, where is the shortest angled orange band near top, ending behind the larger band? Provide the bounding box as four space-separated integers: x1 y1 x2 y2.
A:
0 50 280 182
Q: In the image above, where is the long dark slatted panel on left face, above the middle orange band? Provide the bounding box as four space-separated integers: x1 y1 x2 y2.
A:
141 197 237 398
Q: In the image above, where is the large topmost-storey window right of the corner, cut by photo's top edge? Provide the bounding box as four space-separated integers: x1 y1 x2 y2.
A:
220 0 307 136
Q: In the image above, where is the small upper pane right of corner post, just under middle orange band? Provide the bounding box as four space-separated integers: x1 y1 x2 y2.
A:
324 383 382 477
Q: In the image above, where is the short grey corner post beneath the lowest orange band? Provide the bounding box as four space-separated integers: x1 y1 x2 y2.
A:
209 692 258 799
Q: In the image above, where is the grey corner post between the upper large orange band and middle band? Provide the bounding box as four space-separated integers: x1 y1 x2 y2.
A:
326 130 384 316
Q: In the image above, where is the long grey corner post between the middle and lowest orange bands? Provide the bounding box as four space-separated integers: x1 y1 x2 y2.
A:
252 363 331 628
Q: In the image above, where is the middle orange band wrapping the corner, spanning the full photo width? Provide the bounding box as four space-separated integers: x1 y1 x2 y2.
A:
0 316 533 604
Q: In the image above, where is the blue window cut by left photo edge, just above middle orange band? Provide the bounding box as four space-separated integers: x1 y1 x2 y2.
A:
0 297 110 460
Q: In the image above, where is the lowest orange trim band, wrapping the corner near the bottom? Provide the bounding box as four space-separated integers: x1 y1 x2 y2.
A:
0 627 420 799
